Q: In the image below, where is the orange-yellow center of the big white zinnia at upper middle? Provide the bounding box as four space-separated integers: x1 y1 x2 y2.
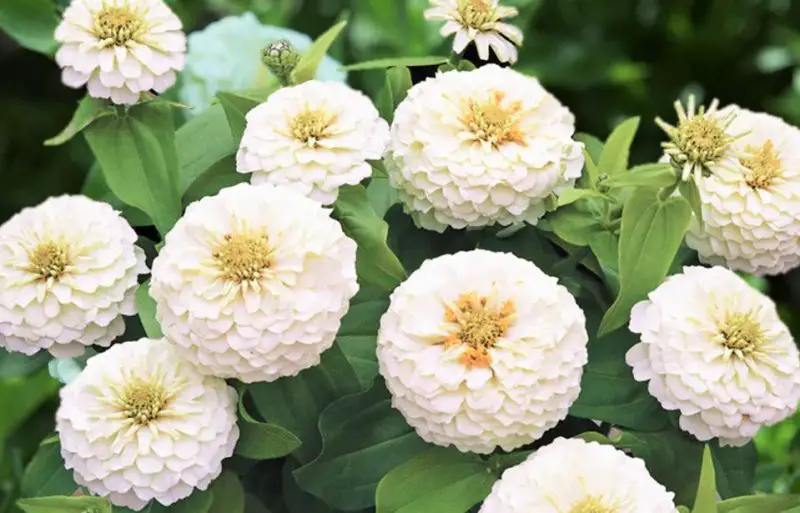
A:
461 91 525 148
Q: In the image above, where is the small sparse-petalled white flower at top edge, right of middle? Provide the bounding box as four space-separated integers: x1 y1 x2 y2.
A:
425 0 523 64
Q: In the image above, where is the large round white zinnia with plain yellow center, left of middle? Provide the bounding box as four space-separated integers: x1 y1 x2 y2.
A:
150 184 358 383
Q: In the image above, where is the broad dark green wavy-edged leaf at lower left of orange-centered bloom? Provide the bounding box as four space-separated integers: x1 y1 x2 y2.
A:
294 382 429 511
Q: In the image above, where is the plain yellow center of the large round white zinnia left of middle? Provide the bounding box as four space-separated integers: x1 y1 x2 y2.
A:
212 233 272 283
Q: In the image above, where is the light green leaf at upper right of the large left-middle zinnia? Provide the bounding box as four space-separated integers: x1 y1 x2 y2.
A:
333 185 406 290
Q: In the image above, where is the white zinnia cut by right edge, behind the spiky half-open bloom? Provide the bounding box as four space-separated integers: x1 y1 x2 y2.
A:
686 106 800 275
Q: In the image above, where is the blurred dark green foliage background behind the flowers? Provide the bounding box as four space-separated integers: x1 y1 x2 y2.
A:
0 0 800 504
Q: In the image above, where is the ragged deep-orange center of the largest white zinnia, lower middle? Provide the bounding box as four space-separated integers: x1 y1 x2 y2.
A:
443 292 516 369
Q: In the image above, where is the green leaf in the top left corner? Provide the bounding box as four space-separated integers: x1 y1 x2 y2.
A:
0 0 59 55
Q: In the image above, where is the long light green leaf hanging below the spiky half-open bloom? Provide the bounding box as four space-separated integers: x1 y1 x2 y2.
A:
600 188 691 335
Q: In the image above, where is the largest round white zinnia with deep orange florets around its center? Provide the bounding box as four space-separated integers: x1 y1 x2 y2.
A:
378 250 588 453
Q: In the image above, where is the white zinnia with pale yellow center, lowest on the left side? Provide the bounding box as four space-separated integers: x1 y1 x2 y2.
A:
56 339 239 511
